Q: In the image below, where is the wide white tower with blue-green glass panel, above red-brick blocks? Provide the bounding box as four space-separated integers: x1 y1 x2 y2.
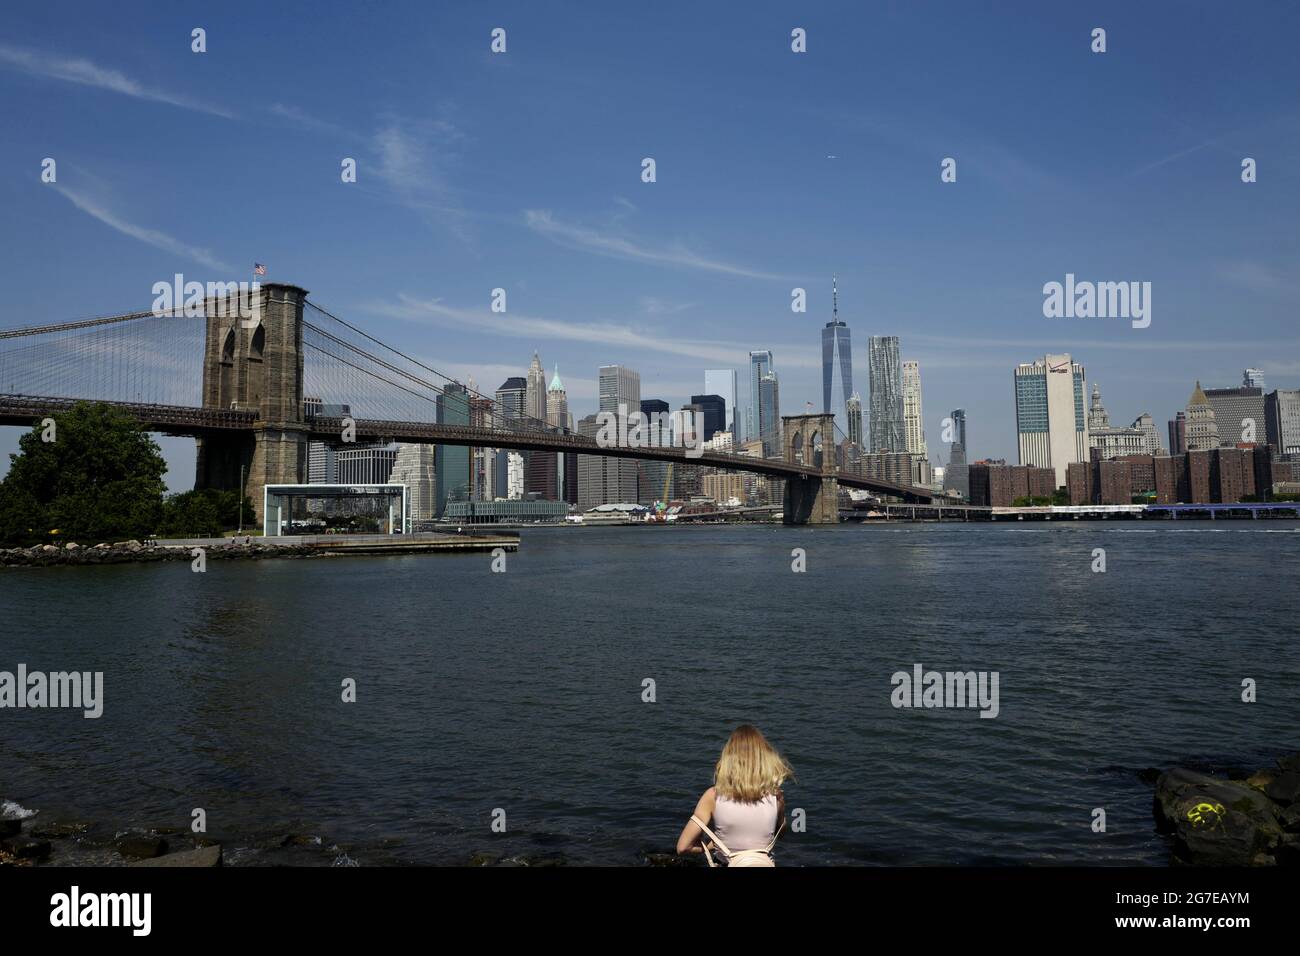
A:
1014 354 1088 488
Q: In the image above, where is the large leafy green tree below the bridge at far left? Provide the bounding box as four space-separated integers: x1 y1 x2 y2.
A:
0 402 166 544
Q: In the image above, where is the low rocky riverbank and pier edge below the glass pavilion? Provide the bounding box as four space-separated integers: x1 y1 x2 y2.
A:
0 532 519 567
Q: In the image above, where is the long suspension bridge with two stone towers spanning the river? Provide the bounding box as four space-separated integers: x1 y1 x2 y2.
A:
0 284 941 524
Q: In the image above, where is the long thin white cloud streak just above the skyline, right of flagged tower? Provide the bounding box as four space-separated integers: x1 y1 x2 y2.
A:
367 294 818 368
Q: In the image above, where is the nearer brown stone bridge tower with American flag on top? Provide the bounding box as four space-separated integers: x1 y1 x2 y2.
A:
195 282 308 520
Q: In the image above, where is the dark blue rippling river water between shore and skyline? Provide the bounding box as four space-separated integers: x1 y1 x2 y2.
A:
0 520 1300 865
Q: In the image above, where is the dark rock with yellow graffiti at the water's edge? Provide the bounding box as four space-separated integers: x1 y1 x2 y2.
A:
1153 767 1282 866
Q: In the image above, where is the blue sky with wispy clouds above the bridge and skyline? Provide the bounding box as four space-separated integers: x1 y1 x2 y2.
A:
0 3 1300 488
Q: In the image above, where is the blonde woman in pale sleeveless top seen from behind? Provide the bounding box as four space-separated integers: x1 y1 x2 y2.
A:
677 723 794 866
